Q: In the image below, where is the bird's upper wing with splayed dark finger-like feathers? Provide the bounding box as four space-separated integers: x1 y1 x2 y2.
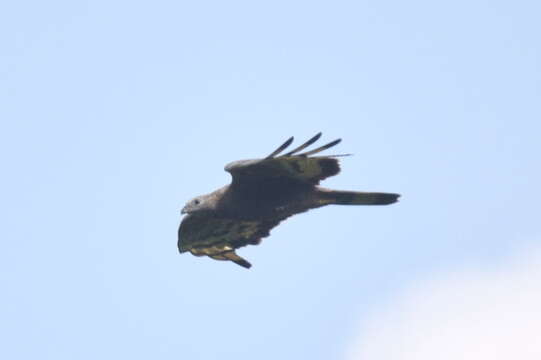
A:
225 133 349 185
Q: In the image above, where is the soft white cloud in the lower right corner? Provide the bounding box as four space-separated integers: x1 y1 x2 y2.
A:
346 250 541 360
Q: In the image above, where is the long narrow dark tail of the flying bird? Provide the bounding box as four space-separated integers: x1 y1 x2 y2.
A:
318 189 400 205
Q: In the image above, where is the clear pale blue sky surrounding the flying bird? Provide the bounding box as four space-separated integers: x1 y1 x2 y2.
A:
0 1 541 360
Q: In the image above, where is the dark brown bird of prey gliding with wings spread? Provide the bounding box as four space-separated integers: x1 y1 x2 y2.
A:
178 133 400 268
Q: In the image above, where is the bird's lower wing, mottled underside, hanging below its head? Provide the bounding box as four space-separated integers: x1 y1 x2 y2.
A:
178 214 283 269
